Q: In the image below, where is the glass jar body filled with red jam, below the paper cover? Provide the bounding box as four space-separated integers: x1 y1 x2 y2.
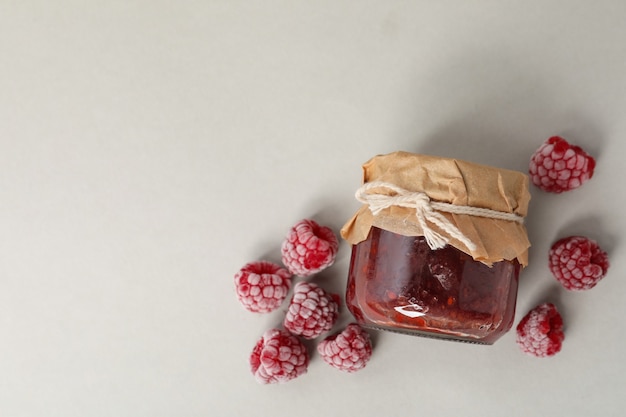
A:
346 227 520 345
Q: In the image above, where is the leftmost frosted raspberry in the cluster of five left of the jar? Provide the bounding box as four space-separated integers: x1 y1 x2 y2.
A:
235 261 291 313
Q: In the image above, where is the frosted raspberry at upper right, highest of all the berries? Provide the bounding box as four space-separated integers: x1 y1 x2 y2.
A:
528 136 596 193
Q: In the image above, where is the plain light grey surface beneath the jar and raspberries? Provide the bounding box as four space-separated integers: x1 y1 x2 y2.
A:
0 0 626 417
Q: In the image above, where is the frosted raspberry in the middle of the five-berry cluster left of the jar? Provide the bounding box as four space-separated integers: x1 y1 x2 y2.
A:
283 282 339 339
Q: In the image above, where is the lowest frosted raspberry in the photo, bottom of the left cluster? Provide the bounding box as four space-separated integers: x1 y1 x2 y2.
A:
250 329 309 384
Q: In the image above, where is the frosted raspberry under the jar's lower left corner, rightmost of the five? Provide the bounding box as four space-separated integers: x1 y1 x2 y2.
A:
317 323 372 372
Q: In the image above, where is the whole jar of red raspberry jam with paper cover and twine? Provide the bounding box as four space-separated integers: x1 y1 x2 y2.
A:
341 152 530 344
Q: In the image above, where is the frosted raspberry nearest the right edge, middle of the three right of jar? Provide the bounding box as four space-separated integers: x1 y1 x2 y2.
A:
549 236 609 291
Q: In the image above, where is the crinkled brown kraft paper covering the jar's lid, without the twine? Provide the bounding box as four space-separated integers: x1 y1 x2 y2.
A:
341 152 530 266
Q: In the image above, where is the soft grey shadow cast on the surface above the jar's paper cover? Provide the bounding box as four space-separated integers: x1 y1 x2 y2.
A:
396 44 606 172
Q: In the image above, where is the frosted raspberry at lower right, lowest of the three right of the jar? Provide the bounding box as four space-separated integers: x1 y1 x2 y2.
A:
516 303 565 358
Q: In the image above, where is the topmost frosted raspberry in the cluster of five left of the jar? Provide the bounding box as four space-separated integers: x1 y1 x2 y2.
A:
281 219 339 277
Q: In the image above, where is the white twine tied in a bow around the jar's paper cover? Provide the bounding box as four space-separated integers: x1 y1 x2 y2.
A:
355 181 524 250
